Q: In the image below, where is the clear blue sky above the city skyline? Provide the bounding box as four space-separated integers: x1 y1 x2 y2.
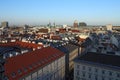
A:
0 0 120 25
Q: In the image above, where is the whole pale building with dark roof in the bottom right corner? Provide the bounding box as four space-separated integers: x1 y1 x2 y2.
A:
74 53 120 80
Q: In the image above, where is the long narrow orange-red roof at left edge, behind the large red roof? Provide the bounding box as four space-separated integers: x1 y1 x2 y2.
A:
0 41 43 49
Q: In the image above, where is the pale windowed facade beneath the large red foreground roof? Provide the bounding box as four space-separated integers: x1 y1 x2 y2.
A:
20 53 65 80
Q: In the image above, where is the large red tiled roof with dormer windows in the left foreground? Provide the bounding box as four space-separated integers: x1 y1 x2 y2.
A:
5 47 64 80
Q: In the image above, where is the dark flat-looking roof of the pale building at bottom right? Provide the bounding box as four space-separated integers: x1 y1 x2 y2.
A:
75 52 120 67
